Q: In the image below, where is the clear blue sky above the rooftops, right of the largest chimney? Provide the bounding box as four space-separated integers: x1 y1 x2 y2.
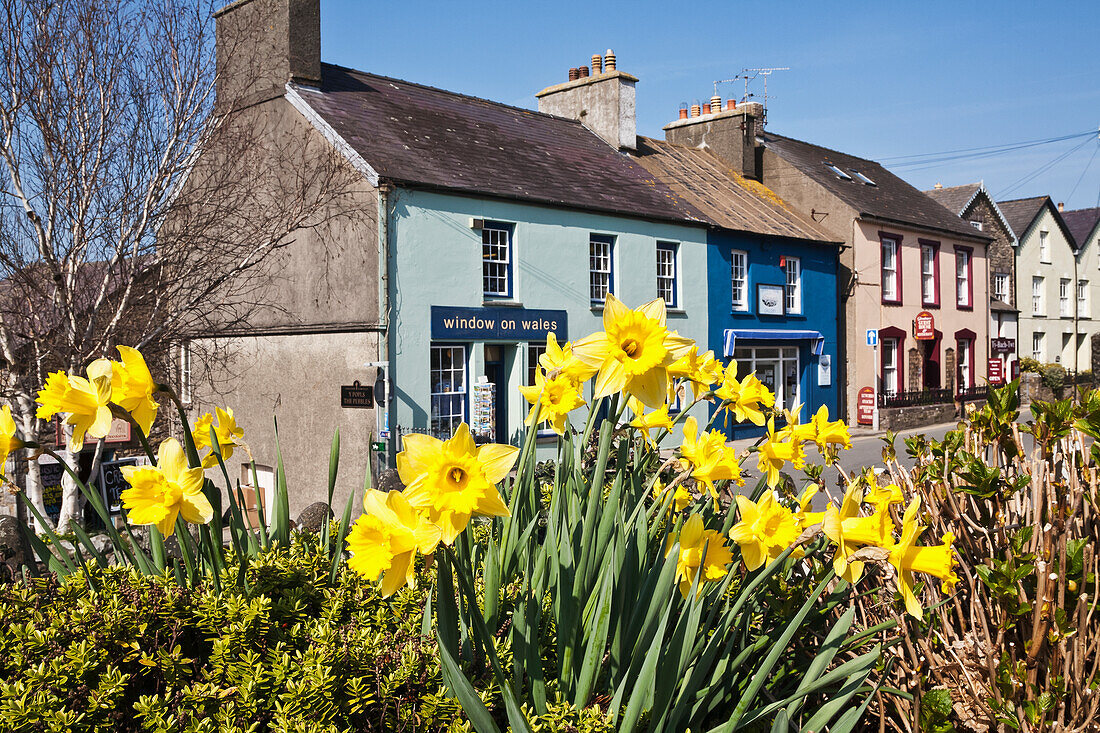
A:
321 0 1100 208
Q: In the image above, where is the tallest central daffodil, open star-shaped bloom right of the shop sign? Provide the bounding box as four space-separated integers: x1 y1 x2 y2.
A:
573 293 692 408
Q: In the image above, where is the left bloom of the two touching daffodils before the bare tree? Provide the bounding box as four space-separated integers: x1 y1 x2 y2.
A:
36 359 114 451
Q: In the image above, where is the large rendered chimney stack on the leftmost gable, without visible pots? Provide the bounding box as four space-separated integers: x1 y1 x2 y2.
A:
213 0 321 110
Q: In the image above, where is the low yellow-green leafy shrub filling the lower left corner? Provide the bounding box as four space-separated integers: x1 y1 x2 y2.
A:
0 538 608 733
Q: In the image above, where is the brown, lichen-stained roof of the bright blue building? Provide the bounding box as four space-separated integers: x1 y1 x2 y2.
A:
635 136 838 243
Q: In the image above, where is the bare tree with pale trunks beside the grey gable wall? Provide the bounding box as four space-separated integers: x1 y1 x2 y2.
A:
0 0 355 528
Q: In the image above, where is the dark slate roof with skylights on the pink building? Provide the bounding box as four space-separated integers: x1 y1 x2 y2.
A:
760 132 990 241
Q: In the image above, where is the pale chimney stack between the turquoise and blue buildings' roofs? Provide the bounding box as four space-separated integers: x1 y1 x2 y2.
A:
535 48 638 151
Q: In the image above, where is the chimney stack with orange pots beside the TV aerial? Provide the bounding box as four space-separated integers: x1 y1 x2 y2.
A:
664 98 763 180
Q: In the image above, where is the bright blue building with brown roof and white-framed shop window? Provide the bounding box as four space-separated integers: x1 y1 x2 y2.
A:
639 134 842 439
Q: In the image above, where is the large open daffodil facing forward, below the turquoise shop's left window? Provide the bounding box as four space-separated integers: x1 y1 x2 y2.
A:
397 423 519 545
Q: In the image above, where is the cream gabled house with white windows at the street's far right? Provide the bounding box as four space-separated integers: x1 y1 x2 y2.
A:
998 196 1086 371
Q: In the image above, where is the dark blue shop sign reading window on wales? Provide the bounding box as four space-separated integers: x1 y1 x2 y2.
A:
431 306 569 341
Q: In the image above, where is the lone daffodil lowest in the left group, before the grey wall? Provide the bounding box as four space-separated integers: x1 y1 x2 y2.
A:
122 438 213 536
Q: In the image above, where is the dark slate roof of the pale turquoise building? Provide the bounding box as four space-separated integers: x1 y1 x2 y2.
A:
296 64 705 222
